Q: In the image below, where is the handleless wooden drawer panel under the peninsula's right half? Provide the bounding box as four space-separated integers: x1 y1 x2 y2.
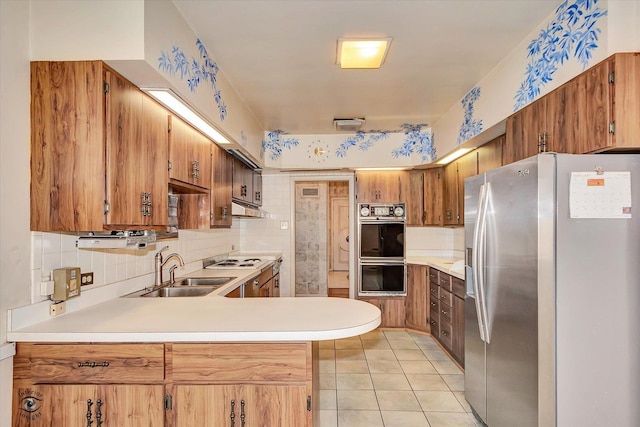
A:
168 343 311 384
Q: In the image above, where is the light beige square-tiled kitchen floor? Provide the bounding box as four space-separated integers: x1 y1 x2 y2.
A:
320 329 481 427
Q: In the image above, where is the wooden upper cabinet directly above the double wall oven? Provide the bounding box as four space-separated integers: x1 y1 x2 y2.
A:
356 171 409 203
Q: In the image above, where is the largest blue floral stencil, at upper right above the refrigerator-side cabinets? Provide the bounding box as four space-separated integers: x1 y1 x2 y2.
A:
513 0 607 111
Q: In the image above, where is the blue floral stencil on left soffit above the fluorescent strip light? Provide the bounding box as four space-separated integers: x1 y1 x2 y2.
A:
158 39 227 120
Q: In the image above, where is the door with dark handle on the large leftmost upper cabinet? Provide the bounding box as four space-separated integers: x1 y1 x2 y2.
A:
105 71 168 228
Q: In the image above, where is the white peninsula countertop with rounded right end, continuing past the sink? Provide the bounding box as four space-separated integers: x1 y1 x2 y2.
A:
7 269 381 342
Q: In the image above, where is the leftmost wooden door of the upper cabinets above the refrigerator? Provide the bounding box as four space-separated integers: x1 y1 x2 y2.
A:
502 97 546 165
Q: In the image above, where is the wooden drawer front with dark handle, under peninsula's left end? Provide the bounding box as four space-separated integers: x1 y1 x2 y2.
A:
31 344 164 384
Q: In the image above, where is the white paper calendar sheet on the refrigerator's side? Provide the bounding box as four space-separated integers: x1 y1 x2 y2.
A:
569 171 631 218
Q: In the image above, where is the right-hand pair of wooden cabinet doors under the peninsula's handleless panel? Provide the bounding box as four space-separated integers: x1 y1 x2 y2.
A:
173 385 309 427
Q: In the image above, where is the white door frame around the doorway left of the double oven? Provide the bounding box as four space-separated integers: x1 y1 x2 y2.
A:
289 172 356 298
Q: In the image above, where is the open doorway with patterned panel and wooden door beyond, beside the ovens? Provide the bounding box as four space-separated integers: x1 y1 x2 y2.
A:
294 180 352 298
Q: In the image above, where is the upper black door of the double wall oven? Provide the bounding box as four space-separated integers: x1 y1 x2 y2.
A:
360 222 404 260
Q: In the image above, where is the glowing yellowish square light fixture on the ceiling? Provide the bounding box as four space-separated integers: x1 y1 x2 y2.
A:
336 37 392 68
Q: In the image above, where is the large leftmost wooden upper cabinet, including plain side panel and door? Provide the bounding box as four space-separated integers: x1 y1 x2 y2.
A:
31 61 168 231
